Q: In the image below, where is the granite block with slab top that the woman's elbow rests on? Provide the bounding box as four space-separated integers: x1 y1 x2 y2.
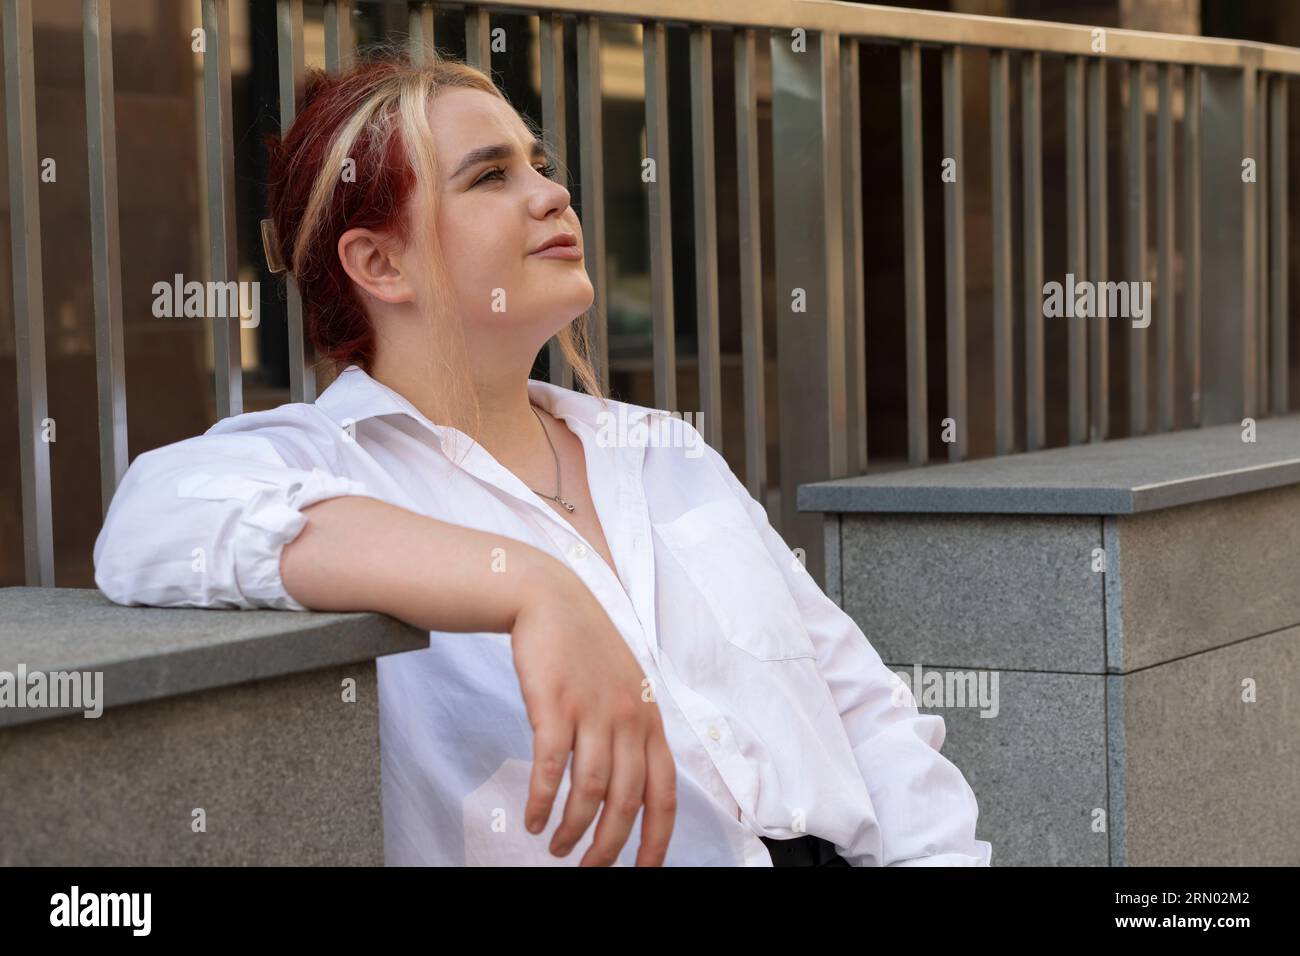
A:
0 588 429 866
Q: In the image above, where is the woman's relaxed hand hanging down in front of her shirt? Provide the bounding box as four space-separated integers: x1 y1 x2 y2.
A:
511 562 677 866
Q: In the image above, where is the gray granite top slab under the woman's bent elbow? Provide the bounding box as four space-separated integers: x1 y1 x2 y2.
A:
0 588 429 727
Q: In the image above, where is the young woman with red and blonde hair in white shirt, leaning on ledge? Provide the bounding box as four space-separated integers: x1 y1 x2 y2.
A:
95 60 991 866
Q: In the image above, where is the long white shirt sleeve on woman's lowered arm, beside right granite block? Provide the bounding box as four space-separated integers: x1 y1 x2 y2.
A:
702 442 992 866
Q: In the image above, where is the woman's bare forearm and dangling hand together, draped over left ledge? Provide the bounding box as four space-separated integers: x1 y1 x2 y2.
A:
280 496 677 866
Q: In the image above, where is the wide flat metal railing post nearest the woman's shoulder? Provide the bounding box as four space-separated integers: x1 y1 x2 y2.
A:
771 30 846 580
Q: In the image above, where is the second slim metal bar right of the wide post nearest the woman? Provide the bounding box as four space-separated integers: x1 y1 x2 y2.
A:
898 43 930 466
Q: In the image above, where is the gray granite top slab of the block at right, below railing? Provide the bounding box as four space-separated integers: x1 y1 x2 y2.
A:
797 415 1300 515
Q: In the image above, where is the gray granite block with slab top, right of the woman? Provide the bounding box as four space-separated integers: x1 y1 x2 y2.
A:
798 416 1300 866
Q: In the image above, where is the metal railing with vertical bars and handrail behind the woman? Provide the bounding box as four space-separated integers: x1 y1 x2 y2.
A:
10 0 1300 585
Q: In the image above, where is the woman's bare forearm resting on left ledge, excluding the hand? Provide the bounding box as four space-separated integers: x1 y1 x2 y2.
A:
280 496 577 633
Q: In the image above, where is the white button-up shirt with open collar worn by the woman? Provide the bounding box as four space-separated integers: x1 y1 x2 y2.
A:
95 365 991 866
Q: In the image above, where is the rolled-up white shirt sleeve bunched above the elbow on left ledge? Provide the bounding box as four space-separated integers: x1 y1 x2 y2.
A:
94 429 373 610
